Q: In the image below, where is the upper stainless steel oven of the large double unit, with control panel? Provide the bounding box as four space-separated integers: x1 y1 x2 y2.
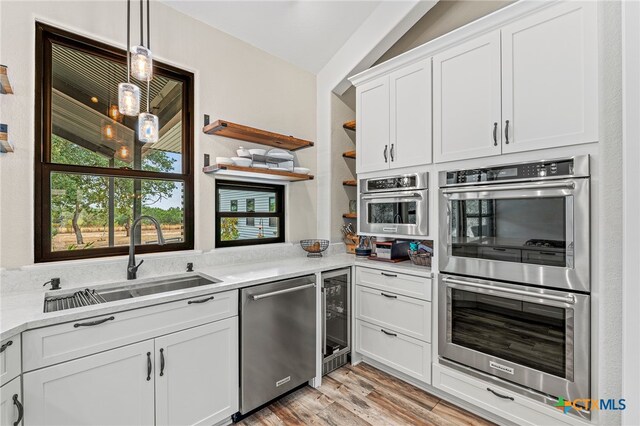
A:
439 156 590 292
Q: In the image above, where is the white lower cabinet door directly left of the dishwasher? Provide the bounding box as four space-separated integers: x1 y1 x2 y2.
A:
156 317 239 425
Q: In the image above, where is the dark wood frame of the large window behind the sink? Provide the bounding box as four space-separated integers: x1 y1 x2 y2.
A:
34 22 194 262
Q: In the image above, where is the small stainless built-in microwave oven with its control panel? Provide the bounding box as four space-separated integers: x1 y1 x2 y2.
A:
358 172 429 237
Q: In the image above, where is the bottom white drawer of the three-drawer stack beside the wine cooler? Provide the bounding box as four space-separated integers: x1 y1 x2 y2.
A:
356 320 431 383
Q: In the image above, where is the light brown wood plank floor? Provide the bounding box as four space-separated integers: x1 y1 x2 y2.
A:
238 363 493 426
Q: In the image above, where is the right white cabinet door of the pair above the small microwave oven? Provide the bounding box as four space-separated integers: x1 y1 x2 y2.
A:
389 59 431 168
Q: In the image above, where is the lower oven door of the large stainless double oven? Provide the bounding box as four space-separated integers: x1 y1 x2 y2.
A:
438 275 590 400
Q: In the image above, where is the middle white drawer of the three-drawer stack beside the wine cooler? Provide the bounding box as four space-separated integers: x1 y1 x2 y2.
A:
356 286 431 342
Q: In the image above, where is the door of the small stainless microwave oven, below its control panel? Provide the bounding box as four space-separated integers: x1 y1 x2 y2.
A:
358 189 429 237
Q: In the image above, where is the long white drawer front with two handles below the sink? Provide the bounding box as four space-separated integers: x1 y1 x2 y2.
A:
23 290 238 371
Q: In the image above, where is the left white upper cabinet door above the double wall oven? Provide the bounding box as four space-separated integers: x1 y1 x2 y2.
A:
433 31 501 163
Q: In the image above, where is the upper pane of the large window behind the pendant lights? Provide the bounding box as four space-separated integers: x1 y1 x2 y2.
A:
51 43 183 173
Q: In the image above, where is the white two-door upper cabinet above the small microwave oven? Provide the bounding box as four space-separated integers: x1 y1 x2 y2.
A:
356 59 431 173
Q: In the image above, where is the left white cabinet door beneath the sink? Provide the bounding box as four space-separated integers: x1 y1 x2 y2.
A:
23 340 154 426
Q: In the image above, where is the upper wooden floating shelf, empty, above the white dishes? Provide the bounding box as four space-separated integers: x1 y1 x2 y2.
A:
202 120 313 151
